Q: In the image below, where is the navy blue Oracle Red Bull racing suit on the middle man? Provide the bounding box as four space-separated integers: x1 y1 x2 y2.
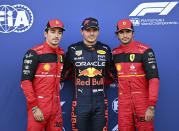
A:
62 42 115 131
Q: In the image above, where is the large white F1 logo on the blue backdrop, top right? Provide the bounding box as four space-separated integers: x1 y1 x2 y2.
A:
129 1 178 16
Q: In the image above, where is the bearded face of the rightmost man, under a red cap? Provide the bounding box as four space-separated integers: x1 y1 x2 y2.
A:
117 29 134 45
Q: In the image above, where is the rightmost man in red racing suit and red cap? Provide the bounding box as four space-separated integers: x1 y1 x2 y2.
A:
113 19 159 131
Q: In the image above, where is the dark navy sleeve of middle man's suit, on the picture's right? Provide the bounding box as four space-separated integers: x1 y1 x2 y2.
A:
105 47 117 85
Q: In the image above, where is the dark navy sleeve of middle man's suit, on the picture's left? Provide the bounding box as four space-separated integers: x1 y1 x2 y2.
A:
60 47 73 81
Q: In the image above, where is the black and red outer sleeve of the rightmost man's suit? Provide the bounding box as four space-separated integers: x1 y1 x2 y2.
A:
143 48 159 106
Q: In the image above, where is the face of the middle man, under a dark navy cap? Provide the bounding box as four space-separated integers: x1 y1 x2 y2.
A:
81 27 99 45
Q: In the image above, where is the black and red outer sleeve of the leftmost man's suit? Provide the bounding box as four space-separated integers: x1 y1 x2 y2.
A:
21 50 38 108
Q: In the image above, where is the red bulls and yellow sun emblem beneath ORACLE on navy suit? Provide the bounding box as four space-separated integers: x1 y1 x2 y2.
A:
78 67 102 77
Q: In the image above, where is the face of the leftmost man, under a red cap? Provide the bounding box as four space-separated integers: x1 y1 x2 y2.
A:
44 28 63 47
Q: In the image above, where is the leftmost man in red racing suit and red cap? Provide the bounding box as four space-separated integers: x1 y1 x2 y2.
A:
21 19 65 131
